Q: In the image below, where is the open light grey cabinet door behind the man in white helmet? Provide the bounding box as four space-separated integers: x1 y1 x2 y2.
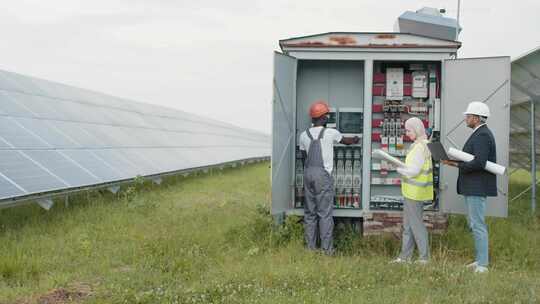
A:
440 57 510 217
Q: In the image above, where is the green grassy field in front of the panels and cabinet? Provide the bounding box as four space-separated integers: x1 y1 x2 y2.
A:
0 163 540 303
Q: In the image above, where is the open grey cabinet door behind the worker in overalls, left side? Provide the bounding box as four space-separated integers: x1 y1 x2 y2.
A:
271 52 297 216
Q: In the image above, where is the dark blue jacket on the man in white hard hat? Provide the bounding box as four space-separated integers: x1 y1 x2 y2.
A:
457 125 497 196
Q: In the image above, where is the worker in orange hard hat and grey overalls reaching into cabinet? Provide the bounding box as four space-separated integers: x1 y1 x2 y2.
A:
299 100 359 255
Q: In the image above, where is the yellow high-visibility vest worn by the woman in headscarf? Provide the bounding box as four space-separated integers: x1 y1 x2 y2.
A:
401 143 433 201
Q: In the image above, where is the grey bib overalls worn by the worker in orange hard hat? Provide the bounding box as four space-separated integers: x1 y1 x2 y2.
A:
304 128 334 254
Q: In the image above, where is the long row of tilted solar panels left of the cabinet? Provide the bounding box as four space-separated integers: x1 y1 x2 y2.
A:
0 71 270 204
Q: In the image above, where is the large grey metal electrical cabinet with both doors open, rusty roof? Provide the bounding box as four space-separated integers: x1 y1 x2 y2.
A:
271 33 510 228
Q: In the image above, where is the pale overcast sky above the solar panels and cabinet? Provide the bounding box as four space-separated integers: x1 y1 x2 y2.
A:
0 0 540 133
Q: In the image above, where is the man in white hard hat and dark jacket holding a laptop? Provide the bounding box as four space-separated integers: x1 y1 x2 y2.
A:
443 101 497 273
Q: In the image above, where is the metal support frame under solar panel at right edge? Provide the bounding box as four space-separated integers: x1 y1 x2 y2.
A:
511 48 540 214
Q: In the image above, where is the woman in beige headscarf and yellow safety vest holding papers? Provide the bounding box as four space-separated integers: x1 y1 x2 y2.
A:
393 117 433 264
